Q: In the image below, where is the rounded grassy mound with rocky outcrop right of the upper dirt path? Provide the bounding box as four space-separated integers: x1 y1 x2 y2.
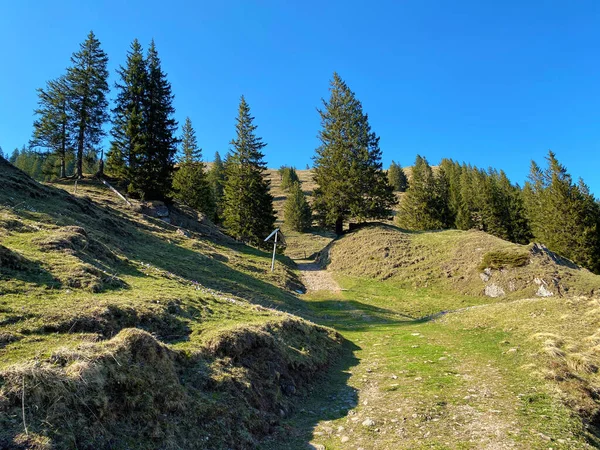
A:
326 225 600 299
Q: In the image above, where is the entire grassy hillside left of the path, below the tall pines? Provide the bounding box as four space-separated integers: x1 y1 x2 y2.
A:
0 158 341 448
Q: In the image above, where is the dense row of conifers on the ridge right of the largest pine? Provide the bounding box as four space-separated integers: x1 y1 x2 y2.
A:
395 151 600 273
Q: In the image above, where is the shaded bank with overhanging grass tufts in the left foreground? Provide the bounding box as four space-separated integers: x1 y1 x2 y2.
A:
0 319 338 449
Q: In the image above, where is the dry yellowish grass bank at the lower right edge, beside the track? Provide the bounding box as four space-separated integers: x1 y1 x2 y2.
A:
441 297 600 436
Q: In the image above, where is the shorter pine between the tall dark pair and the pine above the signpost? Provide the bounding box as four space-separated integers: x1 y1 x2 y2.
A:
173 117 215 219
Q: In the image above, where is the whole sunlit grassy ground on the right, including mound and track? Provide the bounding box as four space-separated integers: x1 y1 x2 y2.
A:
282 226 600 449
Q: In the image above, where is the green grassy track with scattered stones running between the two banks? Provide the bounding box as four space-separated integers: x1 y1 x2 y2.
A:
263 276 589 449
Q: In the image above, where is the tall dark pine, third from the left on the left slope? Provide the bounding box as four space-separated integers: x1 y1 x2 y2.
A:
107 39 148 179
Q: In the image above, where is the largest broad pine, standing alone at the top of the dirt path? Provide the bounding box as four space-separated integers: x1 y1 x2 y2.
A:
313 73 396 234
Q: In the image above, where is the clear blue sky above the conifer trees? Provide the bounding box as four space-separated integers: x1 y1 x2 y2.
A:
0 0 600 196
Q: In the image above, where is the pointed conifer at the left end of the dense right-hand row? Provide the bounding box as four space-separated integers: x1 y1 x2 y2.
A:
396 155 445 230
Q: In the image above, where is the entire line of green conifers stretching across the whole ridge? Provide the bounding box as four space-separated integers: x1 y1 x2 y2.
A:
4 32 600 273
